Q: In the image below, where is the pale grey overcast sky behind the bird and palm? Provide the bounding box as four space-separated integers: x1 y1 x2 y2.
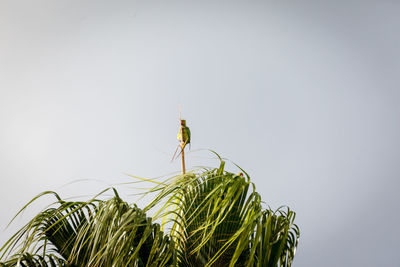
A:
0 0 400 267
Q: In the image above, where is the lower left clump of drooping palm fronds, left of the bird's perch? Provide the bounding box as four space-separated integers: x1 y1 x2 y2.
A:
2 191 175 266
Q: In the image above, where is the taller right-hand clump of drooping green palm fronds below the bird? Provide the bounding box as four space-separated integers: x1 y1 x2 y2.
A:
145 160 298 266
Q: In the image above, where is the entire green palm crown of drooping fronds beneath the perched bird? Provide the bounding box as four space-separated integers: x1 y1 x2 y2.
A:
0 161 299 267
